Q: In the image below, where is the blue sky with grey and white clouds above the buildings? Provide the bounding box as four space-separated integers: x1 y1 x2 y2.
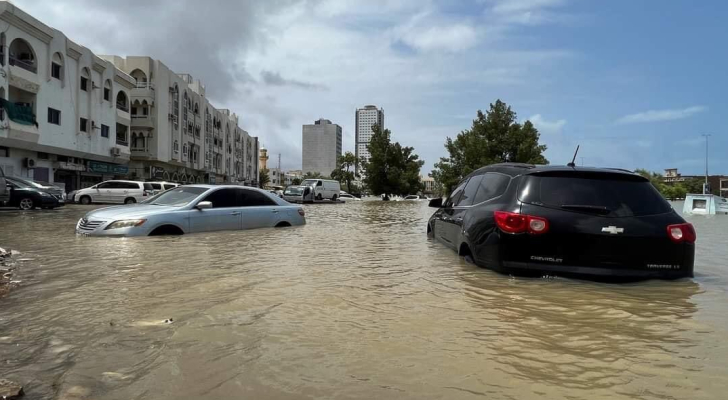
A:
13 0 728 175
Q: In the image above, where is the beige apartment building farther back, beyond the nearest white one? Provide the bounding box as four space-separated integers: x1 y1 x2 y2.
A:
101 56 259 185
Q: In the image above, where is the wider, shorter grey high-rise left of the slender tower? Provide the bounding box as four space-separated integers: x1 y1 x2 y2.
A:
302 118 341 176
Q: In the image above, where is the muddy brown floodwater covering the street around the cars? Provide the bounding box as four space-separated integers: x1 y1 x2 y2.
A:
0 201 728 400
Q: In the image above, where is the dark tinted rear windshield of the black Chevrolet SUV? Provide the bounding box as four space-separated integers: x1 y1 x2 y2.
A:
518 173 672 217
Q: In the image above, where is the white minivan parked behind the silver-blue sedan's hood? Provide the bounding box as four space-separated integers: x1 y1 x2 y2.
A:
74 181 154 204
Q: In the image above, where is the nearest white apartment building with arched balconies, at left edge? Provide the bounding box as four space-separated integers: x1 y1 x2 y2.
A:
0 1 134 191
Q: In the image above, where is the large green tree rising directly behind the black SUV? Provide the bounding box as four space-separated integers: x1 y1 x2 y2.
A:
432 100 548 194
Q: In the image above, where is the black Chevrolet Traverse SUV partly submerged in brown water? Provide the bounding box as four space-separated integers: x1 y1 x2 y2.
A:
427 163 696 279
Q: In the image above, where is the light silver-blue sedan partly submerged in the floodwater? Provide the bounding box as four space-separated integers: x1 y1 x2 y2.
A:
76 185 306 236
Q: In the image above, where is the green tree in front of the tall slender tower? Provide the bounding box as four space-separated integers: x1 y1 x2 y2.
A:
362 125 425 196
